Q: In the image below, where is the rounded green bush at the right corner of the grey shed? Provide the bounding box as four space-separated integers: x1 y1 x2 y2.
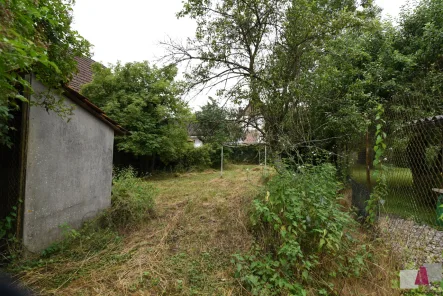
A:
102 167 155 227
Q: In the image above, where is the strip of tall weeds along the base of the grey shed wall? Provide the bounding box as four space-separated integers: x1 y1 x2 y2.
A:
10 168 156 272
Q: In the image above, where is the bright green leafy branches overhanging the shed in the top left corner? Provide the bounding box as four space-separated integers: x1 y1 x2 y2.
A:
0 0 90 146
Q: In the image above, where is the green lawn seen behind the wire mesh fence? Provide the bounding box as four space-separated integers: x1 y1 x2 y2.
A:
351 165 437 226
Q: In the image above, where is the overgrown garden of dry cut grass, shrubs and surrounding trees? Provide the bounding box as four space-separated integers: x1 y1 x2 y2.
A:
0 0 443 295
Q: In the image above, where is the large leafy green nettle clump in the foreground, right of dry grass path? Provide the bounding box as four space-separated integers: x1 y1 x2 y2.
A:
234 164 370 295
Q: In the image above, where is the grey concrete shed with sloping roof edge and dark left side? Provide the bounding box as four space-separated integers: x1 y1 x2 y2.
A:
0 59 125 252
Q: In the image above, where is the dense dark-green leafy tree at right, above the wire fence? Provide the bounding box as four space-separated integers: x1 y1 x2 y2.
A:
306 0 443 205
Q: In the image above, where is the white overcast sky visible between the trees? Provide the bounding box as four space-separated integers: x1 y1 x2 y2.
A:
73 0 412 108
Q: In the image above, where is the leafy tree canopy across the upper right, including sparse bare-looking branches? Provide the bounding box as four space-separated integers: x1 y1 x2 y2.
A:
166 0 443 161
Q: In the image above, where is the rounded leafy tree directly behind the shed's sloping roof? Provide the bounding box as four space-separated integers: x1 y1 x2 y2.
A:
82 62 191 164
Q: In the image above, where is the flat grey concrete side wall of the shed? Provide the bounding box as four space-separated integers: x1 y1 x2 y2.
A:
23 79 114 252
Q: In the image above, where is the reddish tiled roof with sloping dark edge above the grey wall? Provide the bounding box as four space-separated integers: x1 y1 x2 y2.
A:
64 57 128 135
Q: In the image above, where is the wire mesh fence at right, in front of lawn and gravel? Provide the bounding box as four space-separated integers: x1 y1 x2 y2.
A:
350 98 443 264
